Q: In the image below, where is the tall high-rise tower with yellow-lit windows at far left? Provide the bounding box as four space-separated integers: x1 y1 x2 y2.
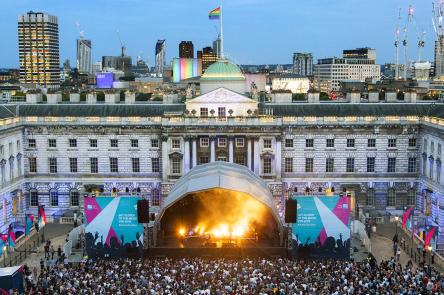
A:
18 11 60 88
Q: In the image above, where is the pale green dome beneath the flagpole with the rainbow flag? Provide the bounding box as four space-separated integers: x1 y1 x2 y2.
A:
201 59 245 81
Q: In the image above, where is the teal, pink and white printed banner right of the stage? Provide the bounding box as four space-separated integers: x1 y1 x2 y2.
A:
292 196 351 259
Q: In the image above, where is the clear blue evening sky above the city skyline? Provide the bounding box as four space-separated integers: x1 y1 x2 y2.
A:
0 0 435 68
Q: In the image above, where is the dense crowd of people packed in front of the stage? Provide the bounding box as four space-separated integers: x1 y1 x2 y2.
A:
26 257 444 295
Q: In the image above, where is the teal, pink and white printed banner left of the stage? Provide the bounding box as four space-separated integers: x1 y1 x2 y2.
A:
84 197 143 258
